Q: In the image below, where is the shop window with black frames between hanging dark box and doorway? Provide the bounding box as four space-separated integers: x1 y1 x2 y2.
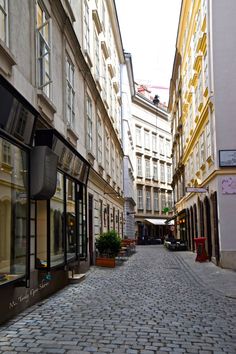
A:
36 172 87 269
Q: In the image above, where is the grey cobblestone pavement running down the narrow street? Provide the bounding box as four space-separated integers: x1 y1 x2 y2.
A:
0 246 236 354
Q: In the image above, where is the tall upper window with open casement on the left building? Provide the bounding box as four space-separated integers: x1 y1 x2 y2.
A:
36 2 52 98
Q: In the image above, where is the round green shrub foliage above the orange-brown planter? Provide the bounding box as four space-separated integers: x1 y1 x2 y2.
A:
96 230 121 258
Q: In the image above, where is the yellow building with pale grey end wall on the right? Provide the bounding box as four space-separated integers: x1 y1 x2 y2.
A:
169 0 236 269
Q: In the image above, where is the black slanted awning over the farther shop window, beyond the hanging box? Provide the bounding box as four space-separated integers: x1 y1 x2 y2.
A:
35 129 90 184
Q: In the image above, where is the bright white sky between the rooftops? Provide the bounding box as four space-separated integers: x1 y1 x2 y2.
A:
116 0 181 104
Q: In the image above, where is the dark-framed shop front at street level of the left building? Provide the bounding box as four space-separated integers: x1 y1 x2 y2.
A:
0 77 89 323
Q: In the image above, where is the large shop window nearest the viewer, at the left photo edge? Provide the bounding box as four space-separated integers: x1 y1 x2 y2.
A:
0 138 29 285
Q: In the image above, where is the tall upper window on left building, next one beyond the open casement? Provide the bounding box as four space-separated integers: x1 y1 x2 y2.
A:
66 58 75 128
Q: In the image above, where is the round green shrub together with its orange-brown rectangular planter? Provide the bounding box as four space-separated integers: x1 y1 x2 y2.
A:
96 230 121 267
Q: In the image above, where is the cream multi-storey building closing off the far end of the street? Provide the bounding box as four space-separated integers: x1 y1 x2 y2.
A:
132 90 173 244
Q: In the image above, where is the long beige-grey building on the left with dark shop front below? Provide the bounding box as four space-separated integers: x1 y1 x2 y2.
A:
0 0 124 321
